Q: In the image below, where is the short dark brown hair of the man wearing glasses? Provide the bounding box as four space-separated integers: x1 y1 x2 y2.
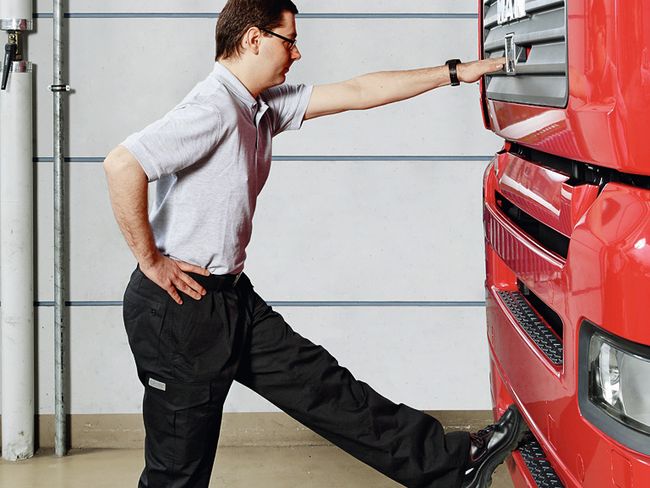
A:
215 0 298 60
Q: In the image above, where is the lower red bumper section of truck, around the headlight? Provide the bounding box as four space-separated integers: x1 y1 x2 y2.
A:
484 154 650 488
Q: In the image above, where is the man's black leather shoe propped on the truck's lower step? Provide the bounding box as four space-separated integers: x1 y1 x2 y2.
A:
462 405 528 488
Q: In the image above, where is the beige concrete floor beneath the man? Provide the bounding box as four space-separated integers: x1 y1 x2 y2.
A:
0 446 512 488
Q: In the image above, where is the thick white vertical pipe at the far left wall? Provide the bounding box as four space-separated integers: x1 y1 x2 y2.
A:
0 59 34 461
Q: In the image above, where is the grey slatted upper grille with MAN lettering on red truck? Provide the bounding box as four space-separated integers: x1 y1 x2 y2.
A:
483 0 568 107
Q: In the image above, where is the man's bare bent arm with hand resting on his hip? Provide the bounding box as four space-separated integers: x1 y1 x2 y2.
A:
104 146 209 304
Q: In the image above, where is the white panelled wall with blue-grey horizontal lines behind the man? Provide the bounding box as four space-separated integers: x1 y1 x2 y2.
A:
0 0 500 413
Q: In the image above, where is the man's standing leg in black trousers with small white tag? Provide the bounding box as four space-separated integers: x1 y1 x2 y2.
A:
124 270 245 488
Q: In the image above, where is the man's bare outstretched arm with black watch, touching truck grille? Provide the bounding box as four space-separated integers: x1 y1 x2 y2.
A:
305 58 505 120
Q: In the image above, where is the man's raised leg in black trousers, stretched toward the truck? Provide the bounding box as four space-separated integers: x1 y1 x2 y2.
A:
235 286 469 488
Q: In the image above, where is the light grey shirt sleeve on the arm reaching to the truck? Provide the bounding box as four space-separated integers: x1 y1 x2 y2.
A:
262 84 313 136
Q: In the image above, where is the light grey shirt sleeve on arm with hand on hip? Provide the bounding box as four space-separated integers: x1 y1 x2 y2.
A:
121 104 222 181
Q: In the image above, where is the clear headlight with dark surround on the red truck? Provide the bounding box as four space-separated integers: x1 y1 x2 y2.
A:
579 322 650 452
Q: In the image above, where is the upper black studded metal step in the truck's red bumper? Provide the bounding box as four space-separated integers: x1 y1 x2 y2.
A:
497 291 564 366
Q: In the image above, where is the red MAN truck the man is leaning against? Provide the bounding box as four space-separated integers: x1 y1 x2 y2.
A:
479 0 650 488
